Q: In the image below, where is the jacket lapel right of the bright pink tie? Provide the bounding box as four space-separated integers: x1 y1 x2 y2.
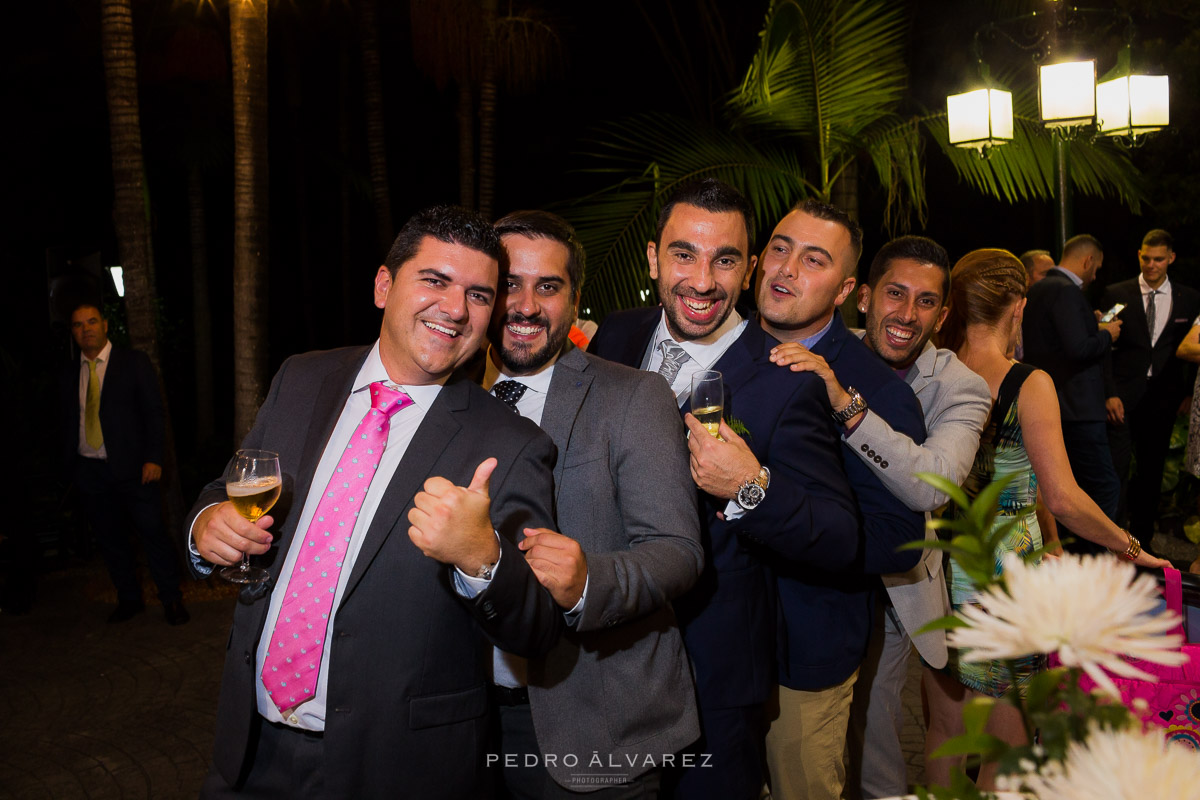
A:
342 378 470 604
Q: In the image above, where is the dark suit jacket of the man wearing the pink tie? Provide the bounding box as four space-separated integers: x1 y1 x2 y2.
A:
187 348 563 800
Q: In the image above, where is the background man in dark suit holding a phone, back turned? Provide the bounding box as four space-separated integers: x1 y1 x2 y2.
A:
1021 234 1121 553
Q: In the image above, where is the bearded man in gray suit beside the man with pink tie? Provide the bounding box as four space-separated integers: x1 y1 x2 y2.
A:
484 211 703 799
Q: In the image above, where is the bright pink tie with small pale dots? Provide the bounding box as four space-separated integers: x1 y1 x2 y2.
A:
263 383 413 712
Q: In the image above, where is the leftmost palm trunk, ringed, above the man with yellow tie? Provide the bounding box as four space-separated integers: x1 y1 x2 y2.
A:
101 0 160 369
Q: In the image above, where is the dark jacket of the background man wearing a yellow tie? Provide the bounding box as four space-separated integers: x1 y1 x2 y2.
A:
59 345 166 482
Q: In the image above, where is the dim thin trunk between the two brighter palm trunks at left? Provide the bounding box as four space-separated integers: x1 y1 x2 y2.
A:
187 166 216 446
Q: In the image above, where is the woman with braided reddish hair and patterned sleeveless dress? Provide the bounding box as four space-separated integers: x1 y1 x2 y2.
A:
923 249 1169 789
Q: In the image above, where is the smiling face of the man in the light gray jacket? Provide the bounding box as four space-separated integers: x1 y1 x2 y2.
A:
858 258 949 369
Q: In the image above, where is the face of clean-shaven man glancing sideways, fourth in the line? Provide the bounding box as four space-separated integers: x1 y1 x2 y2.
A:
758 210 854 342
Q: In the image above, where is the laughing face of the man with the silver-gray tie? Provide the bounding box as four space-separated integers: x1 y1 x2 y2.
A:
646 203 756 342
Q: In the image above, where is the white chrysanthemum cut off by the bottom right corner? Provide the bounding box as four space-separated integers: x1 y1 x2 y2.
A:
1022 726 1200 800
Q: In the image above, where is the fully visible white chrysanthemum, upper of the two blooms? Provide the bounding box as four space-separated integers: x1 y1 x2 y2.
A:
947 553 1187 696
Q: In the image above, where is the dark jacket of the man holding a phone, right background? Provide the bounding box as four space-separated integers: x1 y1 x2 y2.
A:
1021 270 1124 422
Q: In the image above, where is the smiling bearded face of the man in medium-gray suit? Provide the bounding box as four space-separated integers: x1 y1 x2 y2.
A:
488 234 578 375
